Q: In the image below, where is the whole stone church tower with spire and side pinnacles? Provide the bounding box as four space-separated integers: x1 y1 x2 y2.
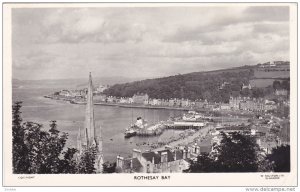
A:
77 73 104 173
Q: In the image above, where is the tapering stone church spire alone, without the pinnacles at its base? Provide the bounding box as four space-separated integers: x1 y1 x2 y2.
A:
85 72 96 144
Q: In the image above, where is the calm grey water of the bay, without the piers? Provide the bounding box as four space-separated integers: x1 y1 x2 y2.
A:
12 84 183 162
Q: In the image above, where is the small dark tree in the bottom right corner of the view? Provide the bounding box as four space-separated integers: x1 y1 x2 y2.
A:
267 145 291 172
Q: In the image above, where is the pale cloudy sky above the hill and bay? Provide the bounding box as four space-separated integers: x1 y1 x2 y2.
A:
12 6 289 80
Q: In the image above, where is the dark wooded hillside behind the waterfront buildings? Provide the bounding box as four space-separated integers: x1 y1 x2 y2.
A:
104 65 288 102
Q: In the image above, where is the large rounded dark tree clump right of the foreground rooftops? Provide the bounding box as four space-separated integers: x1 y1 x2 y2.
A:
186 133 270 173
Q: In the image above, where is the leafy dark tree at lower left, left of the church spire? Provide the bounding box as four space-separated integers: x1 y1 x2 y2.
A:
12 102 77 174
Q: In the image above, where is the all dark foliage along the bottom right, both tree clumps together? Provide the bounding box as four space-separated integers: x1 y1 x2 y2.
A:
185 133 290 173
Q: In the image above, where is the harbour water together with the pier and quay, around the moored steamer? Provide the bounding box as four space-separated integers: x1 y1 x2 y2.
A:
13 86 255 162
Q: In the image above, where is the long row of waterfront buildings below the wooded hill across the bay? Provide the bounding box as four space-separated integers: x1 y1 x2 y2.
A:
55 90 287 112
